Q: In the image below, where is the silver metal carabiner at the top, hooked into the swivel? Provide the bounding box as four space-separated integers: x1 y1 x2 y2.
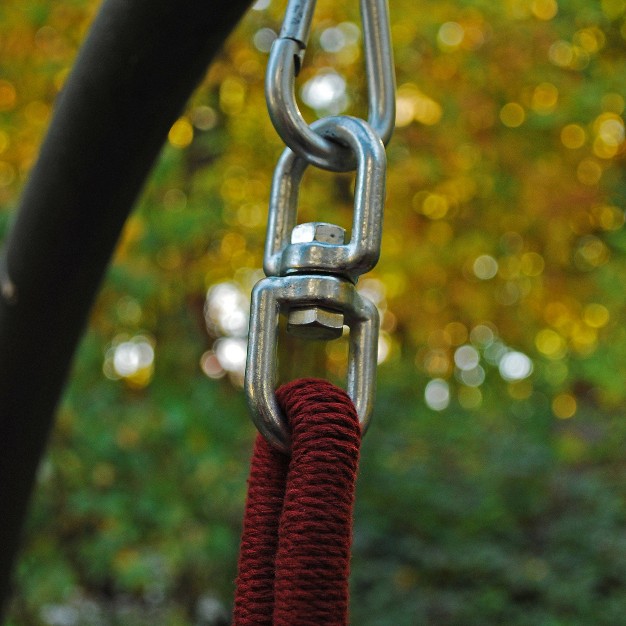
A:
265 0 396 172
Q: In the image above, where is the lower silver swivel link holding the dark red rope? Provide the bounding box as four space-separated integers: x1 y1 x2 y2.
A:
245 275 379 453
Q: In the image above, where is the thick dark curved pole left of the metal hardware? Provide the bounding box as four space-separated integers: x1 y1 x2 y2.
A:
0 0 250 600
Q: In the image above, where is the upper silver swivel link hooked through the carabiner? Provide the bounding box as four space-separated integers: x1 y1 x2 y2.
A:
263 116 386 282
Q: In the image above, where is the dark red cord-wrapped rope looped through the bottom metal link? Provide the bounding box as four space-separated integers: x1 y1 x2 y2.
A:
233 378 361 626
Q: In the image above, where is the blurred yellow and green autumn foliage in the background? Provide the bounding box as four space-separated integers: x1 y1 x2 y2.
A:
0 0 626 626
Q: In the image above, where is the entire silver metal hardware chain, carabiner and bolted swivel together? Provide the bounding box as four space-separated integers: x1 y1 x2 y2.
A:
245 0 395 452
